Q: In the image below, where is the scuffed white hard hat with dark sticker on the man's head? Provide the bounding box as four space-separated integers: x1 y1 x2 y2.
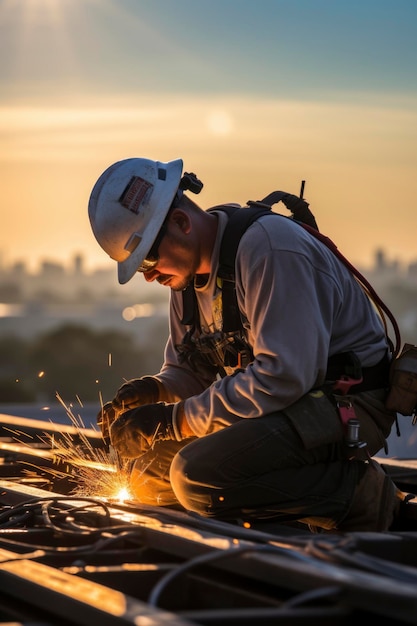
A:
88 158 183 284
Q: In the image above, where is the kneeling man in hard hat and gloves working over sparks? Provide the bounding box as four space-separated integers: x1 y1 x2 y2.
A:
89 158 403 533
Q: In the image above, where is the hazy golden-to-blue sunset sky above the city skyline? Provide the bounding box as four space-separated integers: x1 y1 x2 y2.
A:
0 0 417 282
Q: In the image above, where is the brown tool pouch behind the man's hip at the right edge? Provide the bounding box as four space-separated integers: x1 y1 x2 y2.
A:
385 343 417 415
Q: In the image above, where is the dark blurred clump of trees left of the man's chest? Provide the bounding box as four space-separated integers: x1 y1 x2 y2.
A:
0 324 166 404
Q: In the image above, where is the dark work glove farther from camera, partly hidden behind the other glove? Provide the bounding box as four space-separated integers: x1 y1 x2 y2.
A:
96 376 159 440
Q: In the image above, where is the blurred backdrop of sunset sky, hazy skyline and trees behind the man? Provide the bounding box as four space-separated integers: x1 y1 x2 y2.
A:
0 0 417 448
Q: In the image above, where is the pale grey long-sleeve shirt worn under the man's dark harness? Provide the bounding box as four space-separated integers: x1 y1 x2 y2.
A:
156 211 387 436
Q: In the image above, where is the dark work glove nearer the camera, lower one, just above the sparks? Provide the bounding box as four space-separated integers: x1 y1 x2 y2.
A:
110 402 183 459
